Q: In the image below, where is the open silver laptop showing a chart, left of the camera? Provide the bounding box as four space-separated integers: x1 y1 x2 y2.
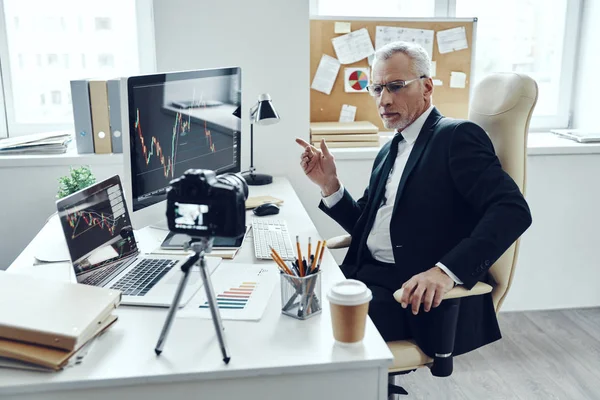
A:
56 175 221 307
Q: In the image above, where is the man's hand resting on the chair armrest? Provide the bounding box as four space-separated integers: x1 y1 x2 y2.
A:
400 267 454 315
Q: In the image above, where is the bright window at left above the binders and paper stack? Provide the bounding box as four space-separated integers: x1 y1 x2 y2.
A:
0 0 155 137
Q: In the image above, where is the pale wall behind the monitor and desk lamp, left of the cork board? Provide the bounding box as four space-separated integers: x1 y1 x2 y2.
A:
154 0 332 247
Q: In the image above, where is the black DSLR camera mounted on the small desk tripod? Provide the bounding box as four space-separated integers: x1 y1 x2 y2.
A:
167 169 248 238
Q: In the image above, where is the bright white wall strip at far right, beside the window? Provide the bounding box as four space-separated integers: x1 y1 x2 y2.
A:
573 0 600 130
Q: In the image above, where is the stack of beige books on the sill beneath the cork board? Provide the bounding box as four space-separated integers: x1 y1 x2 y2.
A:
310 121 379 148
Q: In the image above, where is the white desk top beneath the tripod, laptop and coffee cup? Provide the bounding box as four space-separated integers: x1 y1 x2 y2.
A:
0 178 392 397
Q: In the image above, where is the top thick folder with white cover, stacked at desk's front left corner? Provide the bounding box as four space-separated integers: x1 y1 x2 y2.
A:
0 272 121 351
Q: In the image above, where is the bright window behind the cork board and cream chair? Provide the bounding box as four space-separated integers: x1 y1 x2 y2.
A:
311 0 581 130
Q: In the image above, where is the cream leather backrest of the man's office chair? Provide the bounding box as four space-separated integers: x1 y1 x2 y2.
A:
469 72 538 312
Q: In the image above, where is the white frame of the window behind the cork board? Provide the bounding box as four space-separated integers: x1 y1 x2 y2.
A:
310 0 582 132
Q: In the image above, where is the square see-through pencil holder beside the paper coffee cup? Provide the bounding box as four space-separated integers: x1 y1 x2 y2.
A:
280 271 322 319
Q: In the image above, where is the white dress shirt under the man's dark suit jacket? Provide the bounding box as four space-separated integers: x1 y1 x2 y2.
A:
323 105 462 285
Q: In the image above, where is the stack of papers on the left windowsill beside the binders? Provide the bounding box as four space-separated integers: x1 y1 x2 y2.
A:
0 131 73 155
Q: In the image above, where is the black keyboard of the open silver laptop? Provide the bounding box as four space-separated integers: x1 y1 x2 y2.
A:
111 258 177 296
